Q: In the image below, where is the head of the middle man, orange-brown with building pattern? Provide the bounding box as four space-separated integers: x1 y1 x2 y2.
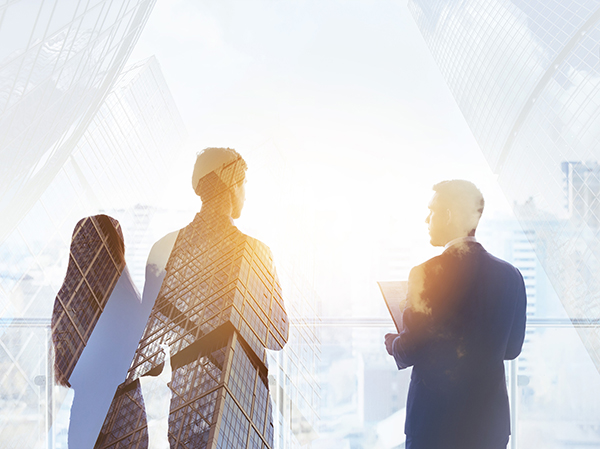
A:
192 148 248 218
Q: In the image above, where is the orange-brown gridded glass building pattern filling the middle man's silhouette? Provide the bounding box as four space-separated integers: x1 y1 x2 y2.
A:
96 157 289 449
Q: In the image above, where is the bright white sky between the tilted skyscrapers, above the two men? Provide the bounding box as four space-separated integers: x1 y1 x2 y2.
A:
132 0 510 316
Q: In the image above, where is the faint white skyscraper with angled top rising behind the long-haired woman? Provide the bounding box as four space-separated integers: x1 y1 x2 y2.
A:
0 54 186 318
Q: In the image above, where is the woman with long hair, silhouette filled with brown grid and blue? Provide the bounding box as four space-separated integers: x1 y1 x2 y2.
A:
52 215 149 449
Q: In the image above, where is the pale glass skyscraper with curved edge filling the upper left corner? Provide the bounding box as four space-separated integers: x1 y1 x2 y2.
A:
0 0 155 241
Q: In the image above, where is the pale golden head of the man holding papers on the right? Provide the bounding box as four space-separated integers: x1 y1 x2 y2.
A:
425 179 484 246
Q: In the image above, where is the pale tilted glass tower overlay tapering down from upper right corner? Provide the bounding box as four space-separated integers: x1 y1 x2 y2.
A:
409 0 600 369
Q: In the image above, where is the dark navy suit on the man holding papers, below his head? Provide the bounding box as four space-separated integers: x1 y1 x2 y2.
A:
393 242 526 449
